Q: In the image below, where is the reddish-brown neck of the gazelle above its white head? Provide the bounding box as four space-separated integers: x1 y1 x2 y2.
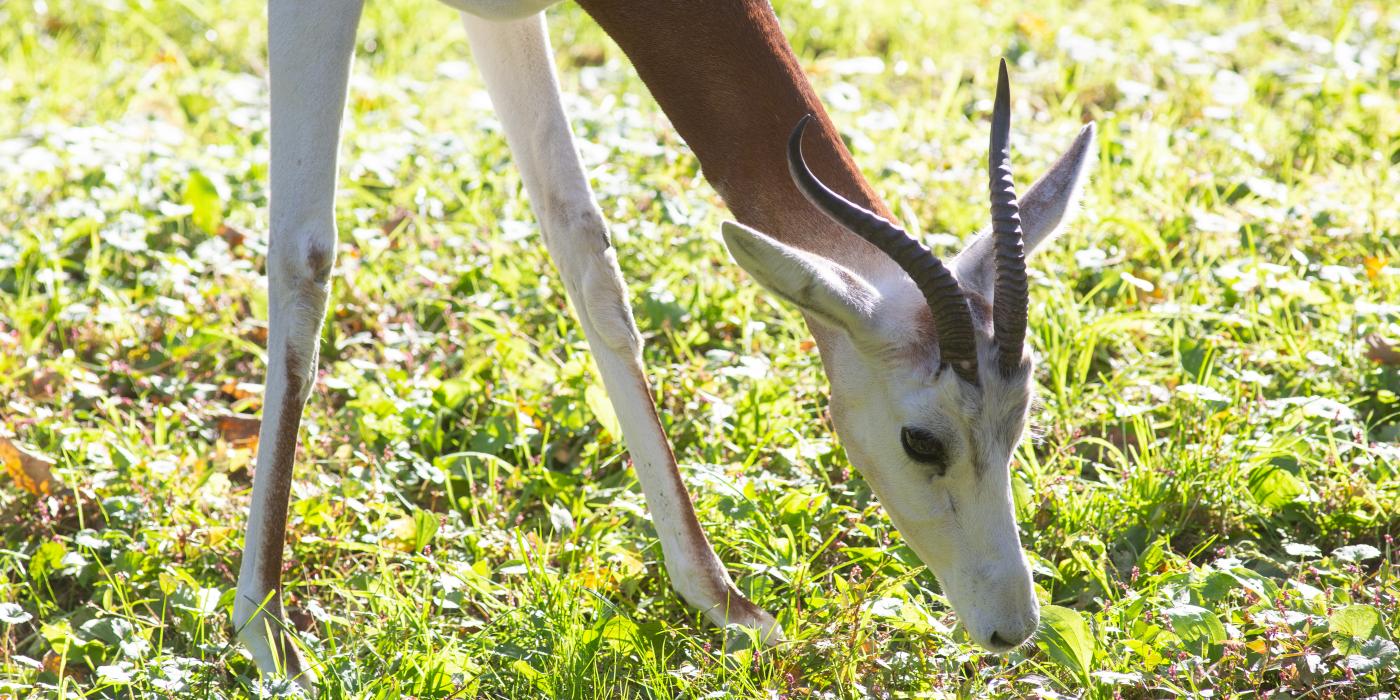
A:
580 0 897 277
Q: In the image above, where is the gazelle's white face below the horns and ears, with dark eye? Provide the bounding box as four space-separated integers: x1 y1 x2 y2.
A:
822 303 1039 652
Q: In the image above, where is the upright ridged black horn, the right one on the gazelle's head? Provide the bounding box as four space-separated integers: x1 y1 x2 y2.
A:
987 59 1029 377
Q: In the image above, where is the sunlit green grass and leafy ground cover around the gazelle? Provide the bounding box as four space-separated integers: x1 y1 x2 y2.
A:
0 0 1400 699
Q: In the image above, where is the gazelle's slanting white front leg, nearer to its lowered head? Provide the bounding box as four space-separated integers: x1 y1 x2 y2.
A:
462 14 783 643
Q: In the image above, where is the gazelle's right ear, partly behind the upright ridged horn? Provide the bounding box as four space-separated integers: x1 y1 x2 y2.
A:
953 122 1098 300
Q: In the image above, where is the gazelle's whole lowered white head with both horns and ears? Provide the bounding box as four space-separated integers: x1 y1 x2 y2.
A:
724 62 1093 652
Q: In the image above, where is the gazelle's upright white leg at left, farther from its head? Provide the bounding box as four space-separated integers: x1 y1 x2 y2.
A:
234 0 363 689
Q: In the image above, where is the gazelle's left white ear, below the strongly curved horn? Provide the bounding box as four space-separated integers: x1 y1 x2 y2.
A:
720 221 879 337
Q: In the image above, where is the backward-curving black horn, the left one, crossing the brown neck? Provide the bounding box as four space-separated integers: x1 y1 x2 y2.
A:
788 115 977 384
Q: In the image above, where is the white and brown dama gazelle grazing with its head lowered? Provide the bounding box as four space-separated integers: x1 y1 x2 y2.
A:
234 0 1093 686
